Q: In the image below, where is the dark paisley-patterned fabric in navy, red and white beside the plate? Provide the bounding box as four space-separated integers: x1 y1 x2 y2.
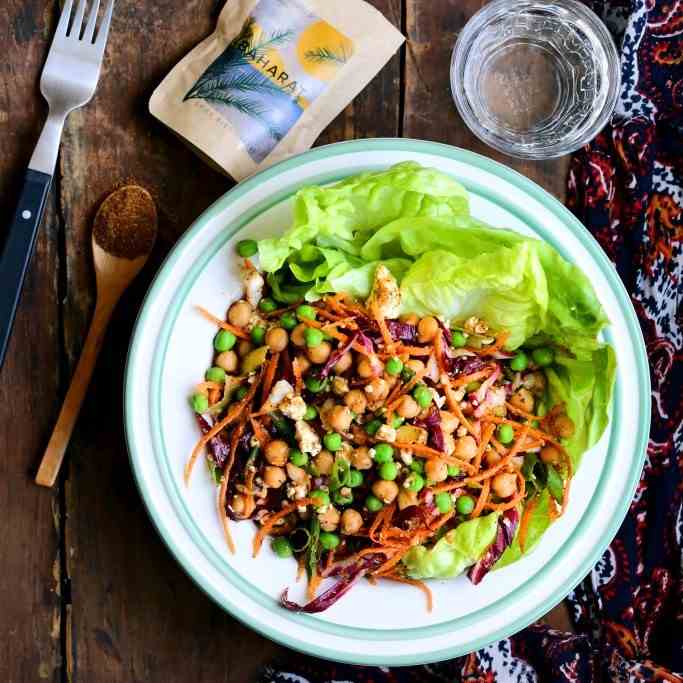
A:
261 0 683 683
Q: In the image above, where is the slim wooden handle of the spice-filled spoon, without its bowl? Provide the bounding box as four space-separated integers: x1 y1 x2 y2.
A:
36 305 113 486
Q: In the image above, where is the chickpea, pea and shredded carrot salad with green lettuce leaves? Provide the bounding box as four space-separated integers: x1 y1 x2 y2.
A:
185 163 615 613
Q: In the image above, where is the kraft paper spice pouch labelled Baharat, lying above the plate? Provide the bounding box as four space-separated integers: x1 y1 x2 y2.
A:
149 0 404 180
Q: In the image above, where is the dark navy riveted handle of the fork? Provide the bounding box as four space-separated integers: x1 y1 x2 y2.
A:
0 168 52 368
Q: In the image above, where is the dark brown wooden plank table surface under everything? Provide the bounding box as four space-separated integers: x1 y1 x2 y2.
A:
0 0 567 683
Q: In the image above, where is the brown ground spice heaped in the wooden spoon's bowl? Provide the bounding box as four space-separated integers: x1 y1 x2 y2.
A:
93 185 158 259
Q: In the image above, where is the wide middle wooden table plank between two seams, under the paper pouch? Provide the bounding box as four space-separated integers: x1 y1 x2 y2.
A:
61 0 401 683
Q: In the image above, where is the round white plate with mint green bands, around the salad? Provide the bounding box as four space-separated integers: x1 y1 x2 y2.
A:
125 140 650 665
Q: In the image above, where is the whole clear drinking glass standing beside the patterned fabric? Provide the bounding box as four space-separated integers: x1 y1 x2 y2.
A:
451 0 620 159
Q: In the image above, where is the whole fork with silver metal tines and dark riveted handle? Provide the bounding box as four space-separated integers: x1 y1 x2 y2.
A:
0 0 114 367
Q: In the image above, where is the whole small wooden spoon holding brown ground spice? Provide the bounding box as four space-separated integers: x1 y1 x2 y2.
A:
36 185 157 486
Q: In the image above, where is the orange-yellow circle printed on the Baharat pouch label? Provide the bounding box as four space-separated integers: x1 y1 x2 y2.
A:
297 21 353 81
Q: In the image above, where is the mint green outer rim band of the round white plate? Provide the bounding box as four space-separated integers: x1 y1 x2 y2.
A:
124 138 650 666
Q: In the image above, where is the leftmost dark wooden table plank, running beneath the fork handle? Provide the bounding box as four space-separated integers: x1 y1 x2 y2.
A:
0 0 61 682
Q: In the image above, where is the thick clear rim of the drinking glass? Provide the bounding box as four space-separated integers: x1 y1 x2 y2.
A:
450 0 621 159
